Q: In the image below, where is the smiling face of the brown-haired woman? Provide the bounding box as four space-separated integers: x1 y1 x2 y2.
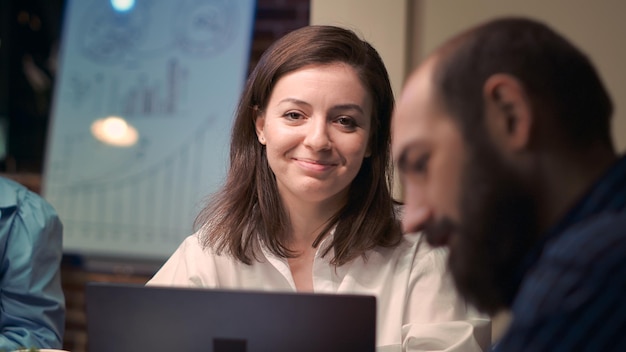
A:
256 63 372 207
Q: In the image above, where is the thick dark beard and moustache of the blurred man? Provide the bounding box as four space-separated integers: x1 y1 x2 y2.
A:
425 140 538 313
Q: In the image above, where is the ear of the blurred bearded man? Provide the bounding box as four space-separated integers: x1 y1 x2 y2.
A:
483 73 533 151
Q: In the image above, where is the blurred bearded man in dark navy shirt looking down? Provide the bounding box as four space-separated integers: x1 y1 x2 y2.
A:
392 18 626 352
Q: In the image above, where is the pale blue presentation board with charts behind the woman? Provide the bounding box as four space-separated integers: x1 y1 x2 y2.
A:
43 0 254 258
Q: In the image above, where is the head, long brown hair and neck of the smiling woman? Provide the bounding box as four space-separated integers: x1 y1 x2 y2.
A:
189 26 402 265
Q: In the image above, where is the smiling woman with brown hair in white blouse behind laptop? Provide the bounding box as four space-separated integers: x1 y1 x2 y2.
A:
149 26 489 351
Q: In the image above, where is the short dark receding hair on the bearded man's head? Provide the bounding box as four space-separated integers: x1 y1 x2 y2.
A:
434 18 613 148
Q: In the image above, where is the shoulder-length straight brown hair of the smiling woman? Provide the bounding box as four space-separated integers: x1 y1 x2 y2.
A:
195 26 402 265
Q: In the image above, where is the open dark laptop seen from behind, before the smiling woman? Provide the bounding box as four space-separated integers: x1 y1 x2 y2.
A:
85 283 376 352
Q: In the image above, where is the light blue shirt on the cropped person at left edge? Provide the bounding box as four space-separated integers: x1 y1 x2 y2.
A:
0 177 65 351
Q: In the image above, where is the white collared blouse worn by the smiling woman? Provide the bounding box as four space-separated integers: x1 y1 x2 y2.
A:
148 233 491 352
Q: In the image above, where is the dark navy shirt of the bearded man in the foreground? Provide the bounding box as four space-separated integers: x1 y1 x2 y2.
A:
495 157 626 352
